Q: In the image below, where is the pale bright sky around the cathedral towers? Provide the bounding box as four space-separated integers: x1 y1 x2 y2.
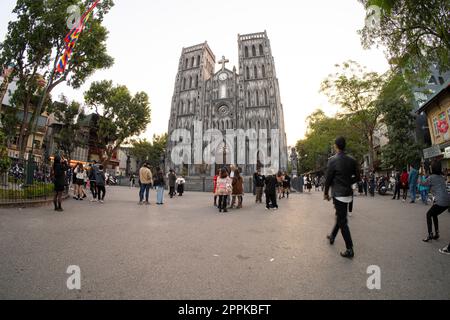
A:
0 0 389 145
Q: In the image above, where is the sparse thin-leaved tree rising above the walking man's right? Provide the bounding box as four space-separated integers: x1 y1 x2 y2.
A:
321 61 384 170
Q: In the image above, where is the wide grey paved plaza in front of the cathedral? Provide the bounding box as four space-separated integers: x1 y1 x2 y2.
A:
0 187 450 300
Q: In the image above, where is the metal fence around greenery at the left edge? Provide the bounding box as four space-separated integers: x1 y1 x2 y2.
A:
0 161 54 205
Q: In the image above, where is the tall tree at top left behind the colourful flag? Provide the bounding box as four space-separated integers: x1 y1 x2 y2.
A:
0 0 114 157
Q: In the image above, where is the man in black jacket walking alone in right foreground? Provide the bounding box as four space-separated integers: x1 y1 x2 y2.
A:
325 137 360 258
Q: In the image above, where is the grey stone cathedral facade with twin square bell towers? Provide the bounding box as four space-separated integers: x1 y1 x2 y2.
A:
166 32 287 176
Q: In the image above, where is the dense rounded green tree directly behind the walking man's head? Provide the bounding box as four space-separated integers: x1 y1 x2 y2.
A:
296 110 367 173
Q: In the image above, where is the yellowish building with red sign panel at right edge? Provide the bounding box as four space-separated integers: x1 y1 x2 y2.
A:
417 80 450 168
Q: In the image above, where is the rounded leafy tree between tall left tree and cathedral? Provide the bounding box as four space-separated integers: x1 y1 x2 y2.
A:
84 81 151 163
